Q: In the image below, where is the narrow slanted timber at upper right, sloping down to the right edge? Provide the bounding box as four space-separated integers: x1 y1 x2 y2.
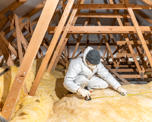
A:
128 8 152 67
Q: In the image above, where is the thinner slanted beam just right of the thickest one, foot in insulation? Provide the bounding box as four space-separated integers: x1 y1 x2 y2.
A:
30 0 74 95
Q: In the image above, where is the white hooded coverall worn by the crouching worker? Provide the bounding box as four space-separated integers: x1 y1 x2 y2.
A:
63 47 121 93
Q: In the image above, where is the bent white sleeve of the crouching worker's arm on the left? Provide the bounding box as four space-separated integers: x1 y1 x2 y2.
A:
63 60 81 93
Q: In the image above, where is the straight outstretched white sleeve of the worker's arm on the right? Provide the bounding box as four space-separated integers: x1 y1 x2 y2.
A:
97 63 121 90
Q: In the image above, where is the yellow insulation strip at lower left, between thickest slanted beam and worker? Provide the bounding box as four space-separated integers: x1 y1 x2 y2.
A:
11 72 58 122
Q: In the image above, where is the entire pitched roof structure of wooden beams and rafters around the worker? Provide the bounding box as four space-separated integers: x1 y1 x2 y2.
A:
0 0 152 119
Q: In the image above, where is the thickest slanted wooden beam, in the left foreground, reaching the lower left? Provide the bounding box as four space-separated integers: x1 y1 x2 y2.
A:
2 0 59 120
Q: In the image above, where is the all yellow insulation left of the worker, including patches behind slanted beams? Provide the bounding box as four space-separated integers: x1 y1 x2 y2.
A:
0 60 59 122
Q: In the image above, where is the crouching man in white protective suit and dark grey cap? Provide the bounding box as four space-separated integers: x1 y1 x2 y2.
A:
63 47 127 97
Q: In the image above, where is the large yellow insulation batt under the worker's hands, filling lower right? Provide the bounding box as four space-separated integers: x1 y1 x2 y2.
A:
47 82 152 122
